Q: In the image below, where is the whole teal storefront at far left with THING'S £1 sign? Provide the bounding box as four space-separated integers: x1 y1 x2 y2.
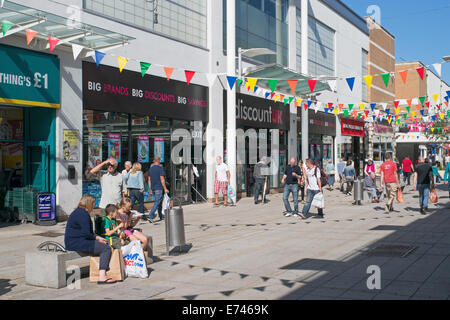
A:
0 45 61 212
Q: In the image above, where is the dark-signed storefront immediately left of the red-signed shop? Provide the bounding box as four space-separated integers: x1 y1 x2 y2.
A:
308 110 336 165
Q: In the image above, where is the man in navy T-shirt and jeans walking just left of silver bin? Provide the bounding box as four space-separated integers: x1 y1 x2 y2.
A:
148 157 169 223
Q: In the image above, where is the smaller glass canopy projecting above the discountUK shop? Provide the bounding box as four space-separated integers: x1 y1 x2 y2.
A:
244 63 331 97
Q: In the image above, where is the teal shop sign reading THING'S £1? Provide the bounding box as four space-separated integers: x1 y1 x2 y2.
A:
0 45 60 108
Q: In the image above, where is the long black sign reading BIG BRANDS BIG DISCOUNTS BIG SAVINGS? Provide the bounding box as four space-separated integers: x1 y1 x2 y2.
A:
83 61 208 122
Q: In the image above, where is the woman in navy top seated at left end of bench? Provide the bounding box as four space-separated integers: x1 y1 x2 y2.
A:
64 195 116 284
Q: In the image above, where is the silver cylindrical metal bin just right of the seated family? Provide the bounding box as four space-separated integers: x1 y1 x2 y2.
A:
164 199 186 255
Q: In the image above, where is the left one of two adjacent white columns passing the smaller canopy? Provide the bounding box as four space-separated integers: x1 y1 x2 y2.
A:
288 0 302 160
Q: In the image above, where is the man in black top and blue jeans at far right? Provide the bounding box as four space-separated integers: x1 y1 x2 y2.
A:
413 156 434 214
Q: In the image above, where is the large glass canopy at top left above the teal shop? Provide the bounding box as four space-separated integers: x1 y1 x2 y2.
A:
0 1 135 50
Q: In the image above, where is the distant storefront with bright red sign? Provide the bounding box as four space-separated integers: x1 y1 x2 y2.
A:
338 117 365 175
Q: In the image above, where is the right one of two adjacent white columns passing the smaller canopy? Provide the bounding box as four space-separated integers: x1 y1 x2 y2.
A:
300 0 309 161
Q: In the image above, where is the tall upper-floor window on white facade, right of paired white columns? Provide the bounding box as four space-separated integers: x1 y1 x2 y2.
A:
296 9 335 76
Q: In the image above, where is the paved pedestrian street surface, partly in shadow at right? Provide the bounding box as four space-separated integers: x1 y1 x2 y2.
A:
0 186 450 300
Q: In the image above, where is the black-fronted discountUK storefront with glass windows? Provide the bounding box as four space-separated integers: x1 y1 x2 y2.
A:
224 92 289 196
